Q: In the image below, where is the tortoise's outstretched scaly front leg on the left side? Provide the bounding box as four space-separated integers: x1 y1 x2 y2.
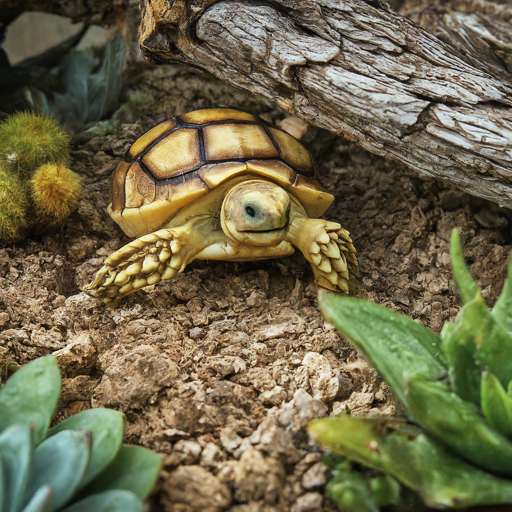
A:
84 217 223 306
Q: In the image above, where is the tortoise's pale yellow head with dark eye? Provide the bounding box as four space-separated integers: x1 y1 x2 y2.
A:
221 180 291 246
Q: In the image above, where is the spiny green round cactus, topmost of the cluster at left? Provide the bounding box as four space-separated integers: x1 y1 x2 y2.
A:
0 112 69 177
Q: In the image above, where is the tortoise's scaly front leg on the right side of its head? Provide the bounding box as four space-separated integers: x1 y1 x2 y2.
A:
287 216 358 293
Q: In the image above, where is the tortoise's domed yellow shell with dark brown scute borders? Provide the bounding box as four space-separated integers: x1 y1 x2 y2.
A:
109 108 334 238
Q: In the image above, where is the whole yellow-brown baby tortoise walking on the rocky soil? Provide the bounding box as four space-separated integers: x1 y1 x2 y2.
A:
85 108 357 304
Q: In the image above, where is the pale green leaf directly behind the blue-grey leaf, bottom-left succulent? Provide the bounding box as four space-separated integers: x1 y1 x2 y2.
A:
48 409 125 488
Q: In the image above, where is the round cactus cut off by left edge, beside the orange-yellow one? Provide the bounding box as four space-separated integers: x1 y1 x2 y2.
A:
0 168 27 241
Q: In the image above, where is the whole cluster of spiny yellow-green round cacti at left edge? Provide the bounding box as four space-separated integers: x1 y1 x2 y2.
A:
0 112 82 241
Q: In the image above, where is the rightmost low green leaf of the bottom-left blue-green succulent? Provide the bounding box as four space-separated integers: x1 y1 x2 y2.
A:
83 445 162 499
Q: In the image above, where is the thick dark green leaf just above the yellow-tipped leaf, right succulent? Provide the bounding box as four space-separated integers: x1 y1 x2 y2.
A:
406 379 512 474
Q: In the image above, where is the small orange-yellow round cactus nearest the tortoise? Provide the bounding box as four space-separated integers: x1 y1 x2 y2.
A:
30 164 82 225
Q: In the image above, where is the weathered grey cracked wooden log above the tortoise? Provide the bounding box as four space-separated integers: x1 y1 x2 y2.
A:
140 0 512 208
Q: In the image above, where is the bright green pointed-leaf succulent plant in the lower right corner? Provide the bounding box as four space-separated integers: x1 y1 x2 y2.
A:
308 230 512 512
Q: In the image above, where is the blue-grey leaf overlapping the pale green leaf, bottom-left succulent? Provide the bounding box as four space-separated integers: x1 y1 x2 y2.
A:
25 430 91 510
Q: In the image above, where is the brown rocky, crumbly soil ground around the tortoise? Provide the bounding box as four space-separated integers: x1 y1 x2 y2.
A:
0 66 512 512
